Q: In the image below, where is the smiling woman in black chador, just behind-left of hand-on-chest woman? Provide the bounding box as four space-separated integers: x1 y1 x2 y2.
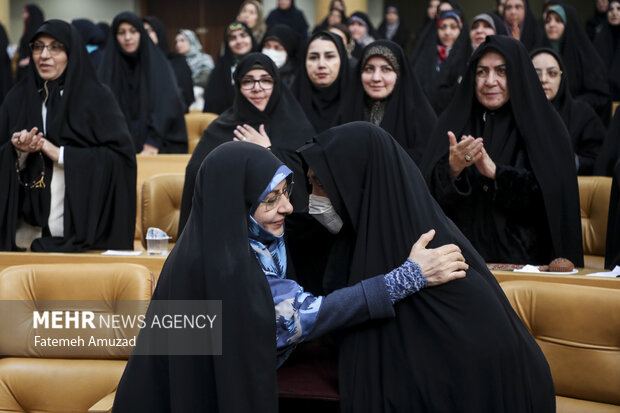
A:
202 21 256 114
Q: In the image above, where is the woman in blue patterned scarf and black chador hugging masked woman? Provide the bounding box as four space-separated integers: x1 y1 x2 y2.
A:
113 138 467 413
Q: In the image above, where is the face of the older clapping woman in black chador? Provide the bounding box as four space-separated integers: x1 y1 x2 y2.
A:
476 51 510 110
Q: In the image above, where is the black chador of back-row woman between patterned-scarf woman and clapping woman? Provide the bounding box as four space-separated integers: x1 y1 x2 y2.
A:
413 9 471 115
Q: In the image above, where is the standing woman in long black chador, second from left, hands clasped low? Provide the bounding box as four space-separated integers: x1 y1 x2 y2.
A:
99 12 187 155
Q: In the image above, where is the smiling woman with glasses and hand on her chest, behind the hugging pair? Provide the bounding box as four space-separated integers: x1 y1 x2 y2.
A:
179 53 314 233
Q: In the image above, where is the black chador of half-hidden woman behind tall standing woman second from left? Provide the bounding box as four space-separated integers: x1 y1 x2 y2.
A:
142 16 194 108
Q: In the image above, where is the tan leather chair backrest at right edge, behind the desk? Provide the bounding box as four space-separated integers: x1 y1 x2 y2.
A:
579 176 611 260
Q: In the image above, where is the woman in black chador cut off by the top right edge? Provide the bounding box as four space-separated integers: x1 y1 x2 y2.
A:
594 0 620 102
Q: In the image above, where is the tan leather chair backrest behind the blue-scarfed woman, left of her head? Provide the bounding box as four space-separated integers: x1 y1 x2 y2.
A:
141 173 185 246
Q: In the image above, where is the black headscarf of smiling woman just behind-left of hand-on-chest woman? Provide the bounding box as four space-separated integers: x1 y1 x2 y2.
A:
202 21 256 114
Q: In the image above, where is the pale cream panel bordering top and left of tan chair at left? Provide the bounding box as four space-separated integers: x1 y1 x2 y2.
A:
134 154 192 240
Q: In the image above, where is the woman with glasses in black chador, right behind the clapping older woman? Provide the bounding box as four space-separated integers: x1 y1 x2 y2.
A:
530 48 605 175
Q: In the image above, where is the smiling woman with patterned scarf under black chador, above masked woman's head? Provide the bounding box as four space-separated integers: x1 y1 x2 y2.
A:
343 40 437 163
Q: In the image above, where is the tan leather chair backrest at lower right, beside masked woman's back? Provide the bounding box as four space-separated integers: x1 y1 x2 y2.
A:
501 281 620 411
